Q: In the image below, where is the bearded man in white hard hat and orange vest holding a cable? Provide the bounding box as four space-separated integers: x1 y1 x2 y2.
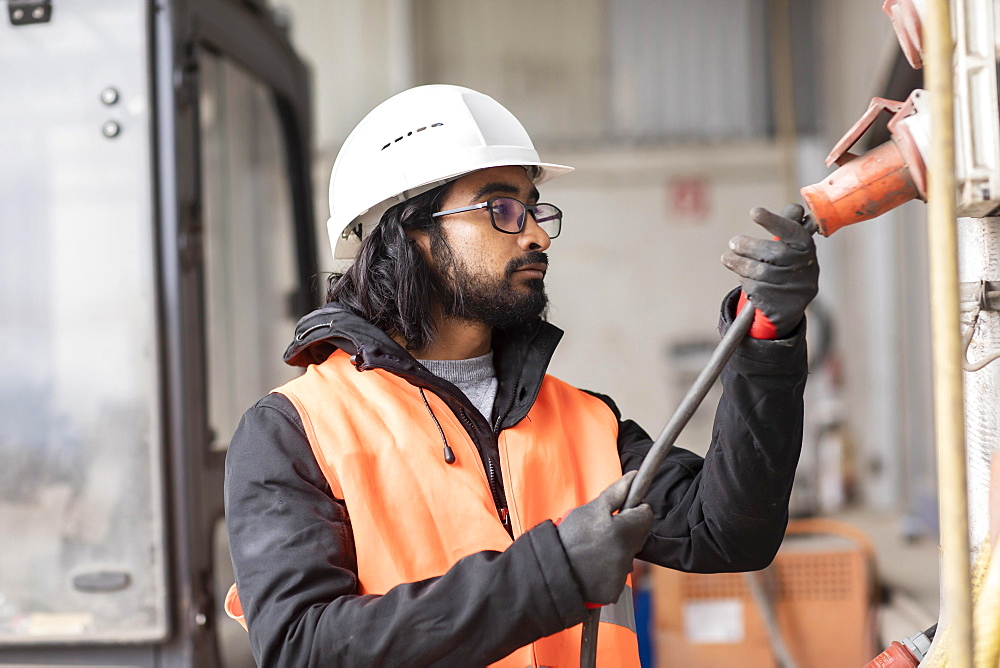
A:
226 86 818 666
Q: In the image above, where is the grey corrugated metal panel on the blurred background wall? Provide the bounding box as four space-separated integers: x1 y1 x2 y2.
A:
609 0 771 140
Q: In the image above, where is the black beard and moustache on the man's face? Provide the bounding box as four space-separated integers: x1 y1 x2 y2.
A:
430 234 549 329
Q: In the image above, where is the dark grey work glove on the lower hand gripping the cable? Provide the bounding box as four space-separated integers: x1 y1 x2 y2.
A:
558 471 653 605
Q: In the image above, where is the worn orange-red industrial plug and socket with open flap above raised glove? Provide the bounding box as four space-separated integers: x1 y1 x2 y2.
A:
801 89 930 236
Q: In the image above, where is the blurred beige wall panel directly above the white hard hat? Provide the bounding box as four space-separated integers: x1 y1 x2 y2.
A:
413 0 609 143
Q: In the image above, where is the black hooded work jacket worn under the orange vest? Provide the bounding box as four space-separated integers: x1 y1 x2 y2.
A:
225 290 806 666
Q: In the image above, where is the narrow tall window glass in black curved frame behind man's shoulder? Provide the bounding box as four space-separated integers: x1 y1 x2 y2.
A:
200 53 300 449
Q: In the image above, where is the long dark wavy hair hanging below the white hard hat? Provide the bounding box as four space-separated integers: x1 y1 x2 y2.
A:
326 183 451 350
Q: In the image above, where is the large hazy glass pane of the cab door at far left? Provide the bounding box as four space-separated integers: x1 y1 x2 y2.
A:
0 0 166 645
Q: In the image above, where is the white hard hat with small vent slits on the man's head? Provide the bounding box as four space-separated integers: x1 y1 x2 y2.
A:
327 84 573 259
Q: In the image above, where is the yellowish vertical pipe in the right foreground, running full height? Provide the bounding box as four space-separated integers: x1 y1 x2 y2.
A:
923 0 972 668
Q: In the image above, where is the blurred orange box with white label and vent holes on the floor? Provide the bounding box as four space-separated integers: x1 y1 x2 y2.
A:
653 519 878 668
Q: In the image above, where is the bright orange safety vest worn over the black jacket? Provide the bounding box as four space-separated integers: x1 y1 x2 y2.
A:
226 350 639 668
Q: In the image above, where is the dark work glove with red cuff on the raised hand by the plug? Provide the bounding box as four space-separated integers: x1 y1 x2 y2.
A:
722 204 819 339
